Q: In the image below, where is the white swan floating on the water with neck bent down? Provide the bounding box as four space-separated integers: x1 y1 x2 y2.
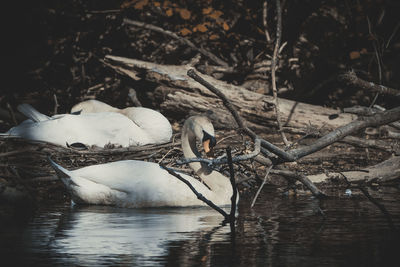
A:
49 116 236 208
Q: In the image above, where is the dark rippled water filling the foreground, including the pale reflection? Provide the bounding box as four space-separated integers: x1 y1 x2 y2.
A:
0 188 400 266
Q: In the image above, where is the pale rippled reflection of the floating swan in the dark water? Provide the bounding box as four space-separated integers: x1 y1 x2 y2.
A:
27 206 230 265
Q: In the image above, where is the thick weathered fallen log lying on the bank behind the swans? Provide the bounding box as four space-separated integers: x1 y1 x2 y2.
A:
105 56 356 133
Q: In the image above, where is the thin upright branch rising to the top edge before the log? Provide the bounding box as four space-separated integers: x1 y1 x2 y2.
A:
271 0 290 147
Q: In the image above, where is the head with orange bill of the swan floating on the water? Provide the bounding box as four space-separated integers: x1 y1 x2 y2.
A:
185 116 217 154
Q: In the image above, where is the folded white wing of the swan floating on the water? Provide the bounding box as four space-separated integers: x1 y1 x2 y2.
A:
73 160 210 207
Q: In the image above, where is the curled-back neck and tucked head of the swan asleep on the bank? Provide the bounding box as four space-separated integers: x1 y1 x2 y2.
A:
71 100 172 143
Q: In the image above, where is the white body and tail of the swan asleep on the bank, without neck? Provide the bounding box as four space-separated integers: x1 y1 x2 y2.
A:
1 104 171 147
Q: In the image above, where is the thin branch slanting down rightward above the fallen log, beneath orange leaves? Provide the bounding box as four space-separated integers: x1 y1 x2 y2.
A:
124 19 229 67
